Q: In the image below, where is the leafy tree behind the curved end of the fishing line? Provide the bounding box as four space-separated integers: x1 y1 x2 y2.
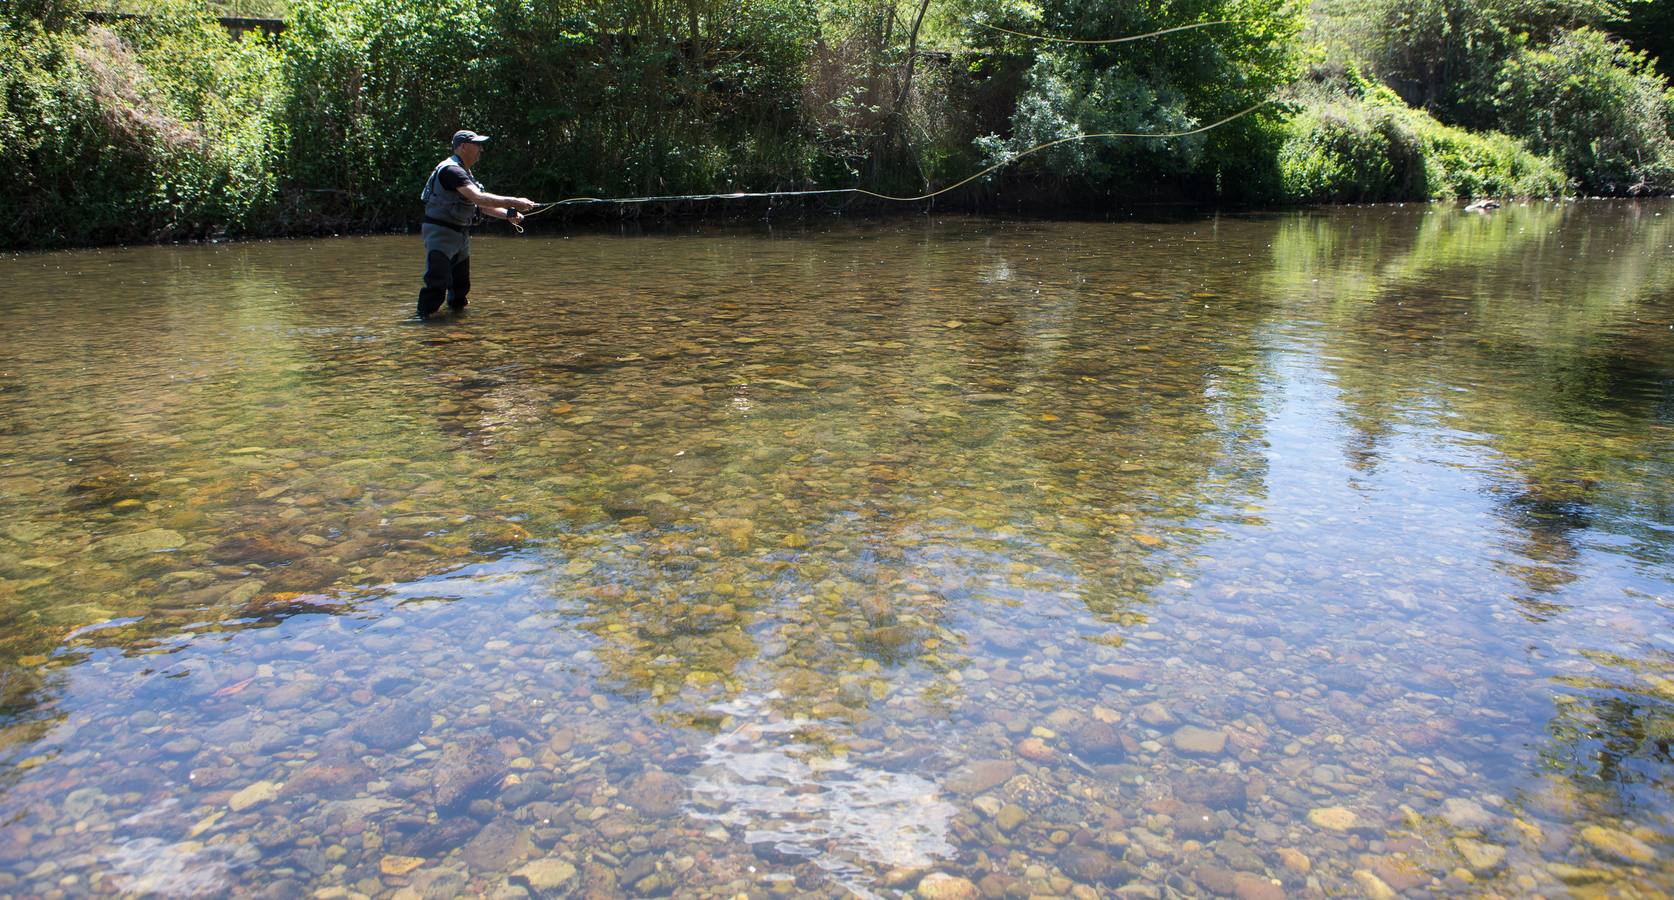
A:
971 0 1302 197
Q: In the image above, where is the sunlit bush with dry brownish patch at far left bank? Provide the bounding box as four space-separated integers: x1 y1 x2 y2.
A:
0 8 278 248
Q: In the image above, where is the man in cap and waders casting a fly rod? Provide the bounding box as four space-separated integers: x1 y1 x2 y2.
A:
419 130 537 320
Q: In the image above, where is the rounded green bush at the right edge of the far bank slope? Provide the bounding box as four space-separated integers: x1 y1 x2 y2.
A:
1495 28 1674 194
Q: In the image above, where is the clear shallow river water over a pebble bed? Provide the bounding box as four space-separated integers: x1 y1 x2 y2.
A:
0 202 1674 900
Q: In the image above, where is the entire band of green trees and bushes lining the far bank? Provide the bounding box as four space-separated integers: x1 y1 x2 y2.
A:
0 0 1674 246
